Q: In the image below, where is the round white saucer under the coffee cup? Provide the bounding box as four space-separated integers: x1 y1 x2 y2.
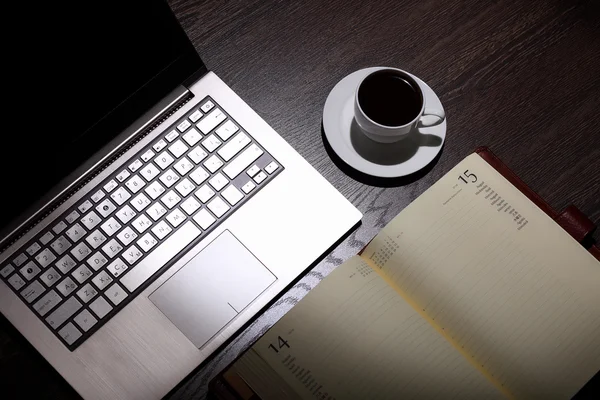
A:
323 67 446 178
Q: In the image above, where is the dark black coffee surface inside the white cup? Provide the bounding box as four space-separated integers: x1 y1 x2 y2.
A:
358 70 423 126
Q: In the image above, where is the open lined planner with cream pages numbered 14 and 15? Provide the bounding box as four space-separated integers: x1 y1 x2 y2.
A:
211 154 600 400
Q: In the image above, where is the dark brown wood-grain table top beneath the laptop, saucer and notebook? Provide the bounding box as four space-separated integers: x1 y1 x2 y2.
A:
0 0 600 398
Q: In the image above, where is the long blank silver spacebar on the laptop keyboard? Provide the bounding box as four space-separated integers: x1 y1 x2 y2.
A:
121 221 201 292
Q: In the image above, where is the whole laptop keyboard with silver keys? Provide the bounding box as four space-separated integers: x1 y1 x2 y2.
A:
0 98 283 351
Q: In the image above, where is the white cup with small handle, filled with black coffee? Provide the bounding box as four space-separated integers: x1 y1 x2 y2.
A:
354 68 446 143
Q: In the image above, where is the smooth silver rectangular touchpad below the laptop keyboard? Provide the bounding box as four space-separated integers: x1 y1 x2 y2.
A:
149 231 276 348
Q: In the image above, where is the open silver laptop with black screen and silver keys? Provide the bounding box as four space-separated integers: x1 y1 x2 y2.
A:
0 0 361 399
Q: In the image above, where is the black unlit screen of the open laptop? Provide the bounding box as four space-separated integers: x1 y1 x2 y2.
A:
0 0 204 238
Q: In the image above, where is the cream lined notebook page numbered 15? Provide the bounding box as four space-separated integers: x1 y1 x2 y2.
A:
363 154 600 399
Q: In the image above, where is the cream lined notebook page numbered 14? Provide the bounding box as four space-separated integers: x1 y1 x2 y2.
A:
250 256 503 400
